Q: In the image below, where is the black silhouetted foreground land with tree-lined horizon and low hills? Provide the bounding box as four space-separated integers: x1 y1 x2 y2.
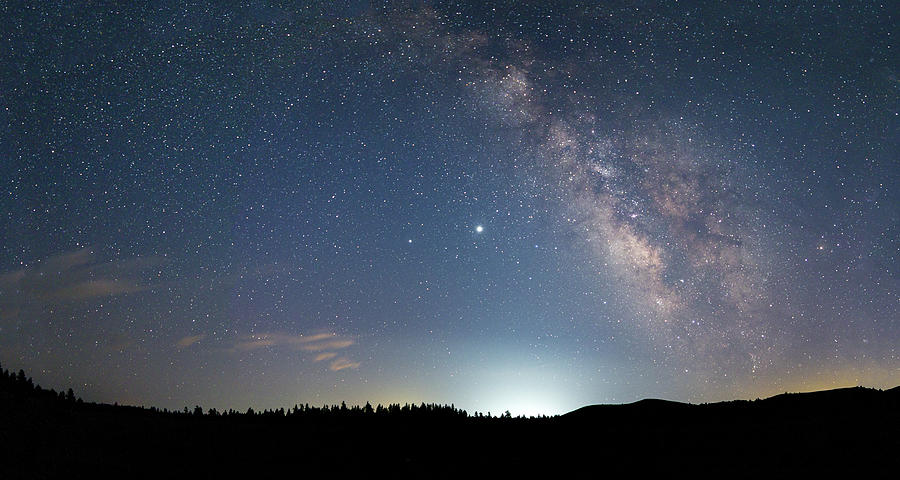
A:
0 364 900 479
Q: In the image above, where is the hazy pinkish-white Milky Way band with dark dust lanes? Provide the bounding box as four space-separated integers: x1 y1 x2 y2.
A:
384 7 786 376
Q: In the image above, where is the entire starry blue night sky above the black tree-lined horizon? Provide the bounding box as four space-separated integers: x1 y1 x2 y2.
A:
0 1 900 414
